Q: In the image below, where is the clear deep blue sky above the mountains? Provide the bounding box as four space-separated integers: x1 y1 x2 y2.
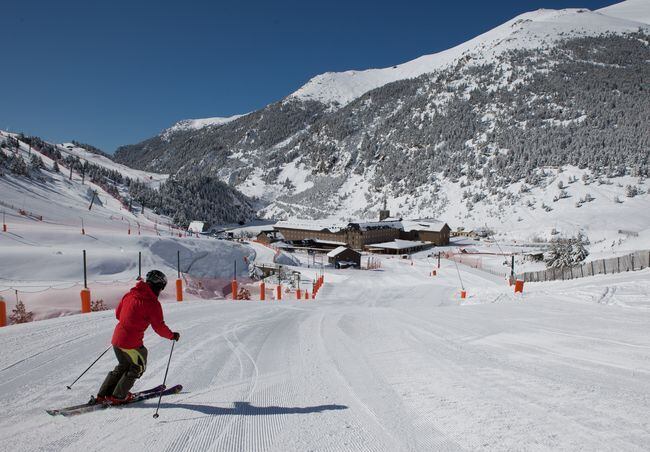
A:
0 0 616 152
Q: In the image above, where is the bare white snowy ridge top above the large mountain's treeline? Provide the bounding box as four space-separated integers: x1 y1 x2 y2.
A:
290 0 650 106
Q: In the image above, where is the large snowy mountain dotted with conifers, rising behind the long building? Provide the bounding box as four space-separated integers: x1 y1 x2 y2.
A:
116 0 650 245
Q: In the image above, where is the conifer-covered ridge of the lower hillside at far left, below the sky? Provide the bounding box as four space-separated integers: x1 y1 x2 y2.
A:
0 131 255 227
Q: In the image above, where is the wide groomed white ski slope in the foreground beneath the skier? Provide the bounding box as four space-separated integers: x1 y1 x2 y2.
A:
0 259 650 451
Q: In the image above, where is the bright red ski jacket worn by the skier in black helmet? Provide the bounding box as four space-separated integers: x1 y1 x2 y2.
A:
111 281 174 349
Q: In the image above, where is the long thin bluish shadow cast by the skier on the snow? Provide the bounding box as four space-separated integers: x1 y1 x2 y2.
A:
142 402 348 421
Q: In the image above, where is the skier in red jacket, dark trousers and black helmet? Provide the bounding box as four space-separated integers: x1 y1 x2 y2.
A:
91 270 180 405
